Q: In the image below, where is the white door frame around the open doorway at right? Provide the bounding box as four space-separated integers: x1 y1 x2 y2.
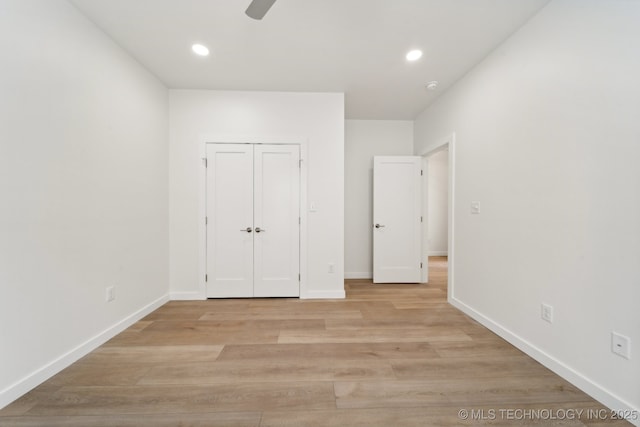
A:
418 132 456 303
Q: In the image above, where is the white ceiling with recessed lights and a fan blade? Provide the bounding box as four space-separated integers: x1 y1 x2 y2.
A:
71 0 549 120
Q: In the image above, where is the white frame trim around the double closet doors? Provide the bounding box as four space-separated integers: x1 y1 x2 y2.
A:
197 135 309 300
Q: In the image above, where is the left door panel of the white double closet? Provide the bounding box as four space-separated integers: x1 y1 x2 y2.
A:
206 144 254 298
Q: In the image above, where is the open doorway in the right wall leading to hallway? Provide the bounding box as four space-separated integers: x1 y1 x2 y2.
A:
421 134 455 300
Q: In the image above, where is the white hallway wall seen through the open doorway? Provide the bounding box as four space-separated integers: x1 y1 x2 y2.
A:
427 150 449 256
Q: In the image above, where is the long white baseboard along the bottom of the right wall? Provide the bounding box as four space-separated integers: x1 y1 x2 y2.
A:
449 297 640 426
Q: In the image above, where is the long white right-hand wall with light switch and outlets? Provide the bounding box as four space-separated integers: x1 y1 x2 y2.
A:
415 0 640 414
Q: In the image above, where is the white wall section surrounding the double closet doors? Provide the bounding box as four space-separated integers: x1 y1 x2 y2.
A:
169 90 344 299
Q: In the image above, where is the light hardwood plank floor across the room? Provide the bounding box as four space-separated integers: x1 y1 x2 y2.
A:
0 258 629 427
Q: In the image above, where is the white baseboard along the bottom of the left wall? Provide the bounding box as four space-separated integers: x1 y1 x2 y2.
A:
0 295 169 409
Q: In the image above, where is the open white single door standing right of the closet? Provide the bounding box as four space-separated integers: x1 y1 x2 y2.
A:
373 156 426 283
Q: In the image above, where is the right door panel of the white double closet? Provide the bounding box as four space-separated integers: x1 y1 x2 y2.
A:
253 145 300 297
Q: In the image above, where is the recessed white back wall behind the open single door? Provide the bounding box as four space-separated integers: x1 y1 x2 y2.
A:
344 120 413 279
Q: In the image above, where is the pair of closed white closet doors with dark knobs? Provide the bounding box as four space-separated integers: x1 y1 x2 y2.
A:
206 144 300 298
